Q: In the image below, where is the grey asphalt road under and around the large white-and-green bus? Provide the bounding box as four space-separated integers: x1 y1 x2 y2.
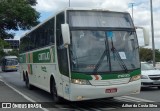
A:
0 72 160 111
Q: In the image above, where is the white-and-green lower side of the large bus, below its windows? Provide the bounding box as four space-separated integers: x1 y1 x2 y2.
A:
20 46 63 96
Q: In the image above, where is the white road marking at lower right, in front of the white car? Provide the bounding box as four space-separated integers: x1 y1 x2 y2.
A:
117 96 155 102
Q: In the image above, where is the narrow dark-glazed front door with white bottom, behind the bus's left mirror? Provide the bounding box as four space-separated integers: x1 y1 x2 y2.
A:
56 12 70 100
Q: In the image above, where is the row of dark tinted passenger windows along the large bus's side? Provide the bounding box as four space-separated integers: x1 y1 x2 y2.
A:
20 18 54 53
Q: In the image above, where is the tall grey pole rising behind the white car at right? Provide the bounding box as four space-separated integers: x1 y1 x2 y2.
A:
150 0 155 67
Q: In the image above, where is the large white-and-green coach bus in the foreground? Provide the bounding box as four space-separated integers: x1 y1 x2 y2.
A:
19 8 148 102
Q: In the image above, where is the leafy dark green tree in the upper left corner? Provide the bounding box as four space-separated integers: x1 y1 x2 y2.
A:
0 0 40 39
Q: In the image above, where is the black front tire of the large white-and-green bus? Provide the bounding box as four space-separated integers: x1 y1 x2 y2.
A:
51 80 61 103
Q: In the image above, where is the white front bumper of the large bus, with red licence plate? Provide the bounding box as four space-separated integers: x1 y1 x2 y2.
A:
70 80 141 101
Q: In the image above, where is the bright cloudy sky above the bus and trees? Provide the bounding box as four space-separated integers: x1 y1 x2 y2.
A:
15 0 160 49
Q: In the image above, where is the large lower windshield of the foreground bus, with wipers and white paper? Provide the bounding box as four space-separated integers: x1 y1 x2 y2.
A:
70 30 140 73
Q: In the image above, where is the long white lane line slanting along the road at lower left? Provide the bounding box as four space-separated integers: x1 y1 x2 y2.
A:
0 79 49 111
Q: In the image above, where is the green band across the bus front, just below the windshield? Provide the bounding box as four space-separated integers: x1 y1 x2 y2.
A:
71 69 141 80
